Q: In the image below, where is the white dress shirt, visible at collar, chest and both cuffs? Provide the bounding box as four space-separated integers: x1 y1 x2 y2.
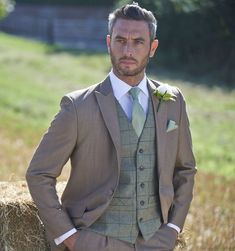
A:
55 71 180 245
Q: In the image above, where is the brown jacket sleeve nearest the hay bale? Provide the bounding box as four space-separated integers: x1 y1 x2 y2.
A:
26 96 77 239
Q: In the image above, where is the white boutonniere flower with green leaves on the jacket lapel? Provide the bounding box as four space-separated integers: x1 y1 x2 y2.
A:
153 84 176 112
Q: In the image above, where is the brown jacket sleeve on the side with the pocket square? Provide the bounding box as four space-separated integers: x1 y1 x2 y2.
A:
168 90 196 230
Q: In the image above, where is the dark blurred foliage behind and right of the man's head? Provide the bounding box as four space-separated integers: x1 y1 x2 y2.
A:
11 0 235 86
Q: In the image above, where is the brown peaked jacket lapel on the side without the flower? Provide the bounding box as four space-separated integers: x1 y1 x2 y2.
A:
95 77 120 167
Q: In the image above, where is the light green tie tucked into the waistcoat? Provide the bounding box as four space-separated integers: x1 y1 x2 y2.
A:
129 87 146 137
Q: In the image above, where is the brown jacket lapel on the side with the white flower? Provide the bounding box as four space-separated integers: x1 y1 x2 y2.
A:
148 79 167 177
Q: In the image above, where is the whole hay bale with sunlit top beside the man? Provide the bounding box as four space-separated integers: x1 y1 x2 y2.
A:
0 182 64 251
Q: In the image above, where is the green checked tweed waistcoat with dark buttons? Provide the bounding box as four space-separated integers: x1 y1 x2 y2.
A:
90 97 161 243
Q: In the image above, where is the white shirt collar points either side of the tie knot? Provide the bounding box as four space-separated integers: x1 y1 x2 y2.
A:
109 71 149 100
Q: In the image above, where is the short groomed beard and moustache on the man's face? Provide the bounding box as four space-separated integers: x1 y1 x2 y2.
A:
110 48 150 77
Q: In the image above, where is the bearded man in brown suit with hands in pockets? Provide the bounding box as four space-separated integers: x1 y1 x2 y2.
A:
26 3 196 251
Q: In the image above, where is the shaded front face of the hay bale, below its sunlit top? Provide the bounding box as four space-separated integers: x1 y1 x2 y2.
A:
0 201 50 251
